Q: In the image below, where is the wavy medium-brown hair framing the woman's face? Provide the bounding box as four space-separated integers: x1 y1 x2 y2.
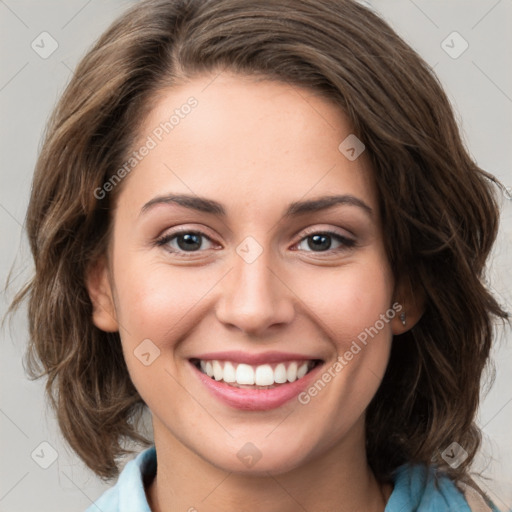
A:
7 0 507 490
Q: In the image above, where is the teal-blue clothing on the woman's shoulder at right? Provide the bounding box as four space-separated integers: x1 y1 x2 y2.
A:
385 464 499 512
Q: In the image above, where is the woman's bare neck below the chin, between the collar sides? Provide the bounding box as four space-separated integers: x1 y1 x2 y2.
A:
146 418 392 512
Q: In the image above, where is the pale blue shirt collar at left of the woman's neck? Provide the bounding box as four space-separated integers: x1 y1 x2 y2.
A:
85 445 156 512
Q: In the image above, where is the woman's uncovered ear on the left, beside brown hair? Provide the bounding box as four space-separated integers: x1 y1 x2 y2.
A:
85 257 119 332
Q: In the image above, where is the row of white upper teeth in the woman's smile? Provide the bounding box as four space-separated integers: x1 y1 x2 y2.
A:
195 360 314 386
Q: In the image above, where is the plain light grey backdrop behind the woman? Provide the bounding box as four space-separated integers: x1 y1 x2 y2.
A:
0 0 512 512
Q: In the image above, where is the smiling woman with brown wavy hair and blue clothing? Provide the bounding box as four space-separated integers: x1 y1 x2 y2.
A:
8 0 507 512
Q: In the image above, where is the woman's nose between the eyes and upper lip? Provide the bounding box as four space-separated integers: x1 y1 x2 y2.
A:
216 240 297 335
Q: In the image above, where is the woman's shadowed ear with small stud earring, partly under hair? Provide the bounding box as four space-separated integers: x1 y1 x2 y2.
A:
391 280 426 334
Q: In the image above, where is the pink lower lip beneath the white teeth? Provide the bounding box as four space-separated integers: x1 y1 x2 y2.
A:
190 363 323 411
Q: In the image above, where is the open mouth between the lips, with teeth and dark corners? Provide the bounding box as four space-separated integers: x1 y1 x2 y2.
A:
190 358 323 390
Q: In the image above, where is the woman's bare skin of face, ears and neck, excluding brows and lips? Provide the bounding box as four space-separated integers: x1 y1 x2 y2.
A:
88 73 420 512
